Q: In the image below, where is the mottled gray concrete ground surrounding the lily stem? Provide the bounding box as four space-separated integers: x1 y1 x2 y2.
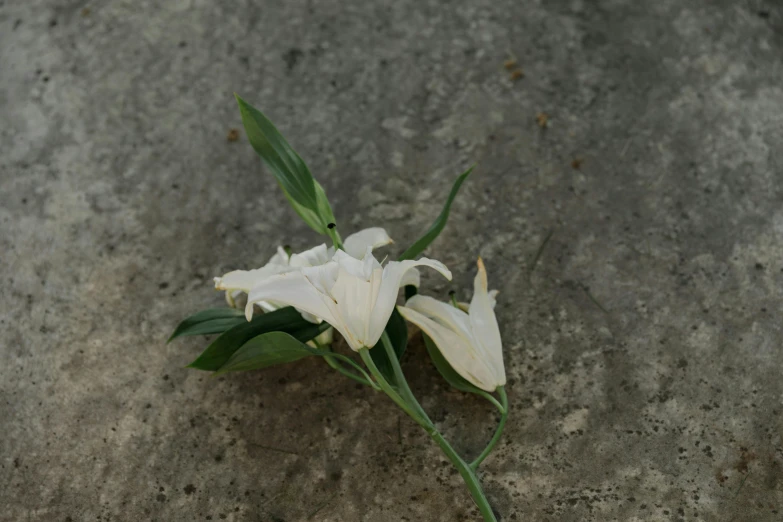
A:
0 0 783 522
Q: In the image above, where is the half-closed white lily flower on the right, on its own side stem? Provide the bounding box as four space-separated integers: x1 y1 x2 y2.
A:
397 258 506 392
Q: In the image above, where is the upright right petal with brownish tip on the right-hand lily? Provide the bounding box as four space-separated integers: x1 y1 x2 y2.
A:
468 258 506 385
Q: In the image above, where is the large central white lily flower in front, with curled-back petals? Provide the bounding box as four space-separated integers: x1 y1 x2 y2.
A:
245 246 451 351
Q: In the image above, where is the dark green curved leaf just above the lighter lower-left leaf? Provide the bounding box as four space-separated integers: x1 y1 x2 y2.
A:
188 306 329 371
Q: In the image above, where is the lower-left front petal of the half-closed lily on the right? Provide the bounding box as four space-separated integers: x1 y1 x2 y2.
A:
397 306 498 392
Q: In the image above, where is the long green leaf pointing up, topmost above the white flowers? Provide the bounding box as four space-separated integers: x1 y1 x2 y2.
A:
235 94 335 234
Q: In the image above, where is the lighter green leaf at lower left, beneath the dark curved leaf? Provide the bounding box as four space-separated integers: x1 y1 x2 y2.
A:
215 332 318 375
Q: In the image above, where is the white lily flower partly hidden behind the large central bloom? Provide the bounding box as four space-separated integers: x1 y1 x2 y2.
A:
215 227 392 323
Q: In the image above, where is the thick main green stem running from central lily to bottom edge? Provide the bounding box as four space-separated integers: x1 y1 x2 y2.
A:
374 332 497 522
